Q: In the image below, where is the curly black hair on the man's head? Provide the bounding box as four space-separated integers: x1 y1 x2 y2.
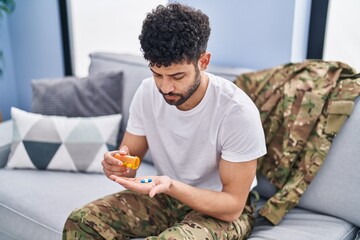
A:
139 3 211 67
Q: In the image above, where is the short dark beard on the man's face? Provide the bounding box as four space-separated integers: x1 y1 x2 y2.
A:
159 66 201 106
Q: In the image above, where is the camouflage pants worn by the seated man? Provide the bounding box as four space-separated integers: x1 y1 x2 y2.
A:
63 191 254 240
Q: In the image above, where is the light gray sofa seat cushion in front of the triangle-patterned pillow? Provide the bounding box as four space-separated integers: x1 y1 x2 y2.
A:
0 163 156 240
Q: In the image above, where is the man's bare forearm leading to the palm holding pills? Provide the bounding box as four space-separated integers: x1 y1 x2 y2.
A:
167 180 248 222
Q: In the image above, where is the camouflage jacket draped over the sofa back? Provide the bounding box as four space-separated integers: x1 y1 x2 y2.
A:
235 60 360 224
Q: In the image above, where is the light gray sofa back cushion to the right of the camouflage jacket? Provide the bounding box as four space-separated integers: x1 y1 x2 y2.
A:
299 97 360 226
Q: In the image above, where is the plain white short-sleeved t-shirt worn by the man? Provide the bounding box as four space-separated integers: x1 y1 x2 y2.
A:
127 73 266 191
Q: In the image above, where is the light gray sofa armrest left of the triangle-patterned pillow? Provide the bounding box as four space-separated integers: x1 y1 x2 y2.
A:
0 120 12 168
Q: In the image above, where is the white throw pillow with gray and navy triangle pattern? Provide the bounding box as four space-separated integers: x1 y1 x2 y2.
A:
7 107 122 173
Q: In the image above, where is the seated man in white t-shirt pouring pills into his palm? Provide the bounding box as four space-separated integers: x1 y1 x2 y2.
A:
63 4 266 239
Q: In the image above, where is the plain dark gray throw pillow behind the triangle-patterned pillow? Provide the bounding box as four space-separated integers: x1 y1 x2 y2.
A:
31 72 123 117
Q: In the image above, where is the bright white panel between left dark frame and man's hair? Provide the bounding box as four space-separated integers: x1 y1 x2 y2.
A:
69 0 167 76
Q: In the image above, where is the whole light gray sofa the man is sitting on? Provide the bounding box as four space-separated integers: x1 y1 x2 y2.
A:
0 53 360 240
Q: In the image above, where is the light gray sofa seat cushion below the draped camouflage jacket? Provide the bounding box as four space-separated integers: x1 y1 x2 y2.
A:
248 200 359 240
